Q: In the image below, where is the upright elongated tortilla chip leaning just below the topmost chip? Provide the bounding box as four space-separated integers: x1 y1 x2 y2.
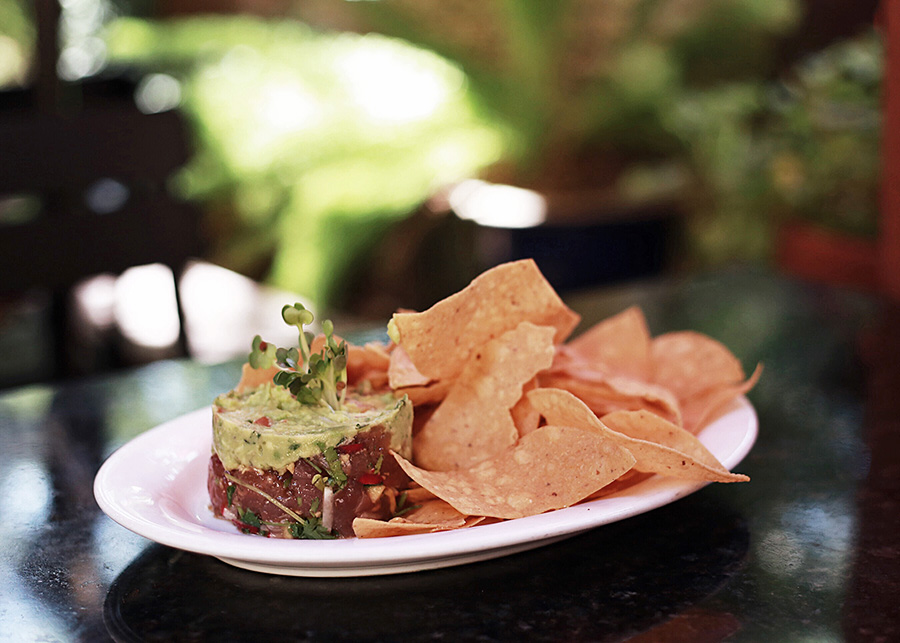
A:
413 322 554 471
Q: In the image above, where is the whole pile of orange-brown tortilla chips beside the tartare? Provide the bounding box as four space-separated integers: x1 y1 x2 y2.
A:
348 260 760 538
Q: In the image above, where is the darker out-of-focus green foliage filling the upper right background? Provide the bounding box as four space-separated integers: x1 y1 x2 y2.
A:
344 0 883 265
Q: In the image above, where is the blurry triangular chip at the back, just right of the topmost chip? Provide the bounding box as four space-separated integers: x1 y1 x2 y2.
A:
566 306 652 380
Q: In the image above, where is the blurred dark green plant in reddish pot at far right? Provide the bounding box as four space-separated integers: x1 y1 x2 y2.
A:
765 30 884 288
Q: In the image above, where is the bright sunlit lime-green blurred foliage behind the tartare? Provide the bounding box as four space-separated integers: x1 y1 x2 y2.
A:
106 16 501 305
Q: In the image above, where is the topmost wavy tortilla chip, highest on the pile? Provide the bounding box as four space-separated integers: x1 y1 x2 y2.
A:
391 259 579 380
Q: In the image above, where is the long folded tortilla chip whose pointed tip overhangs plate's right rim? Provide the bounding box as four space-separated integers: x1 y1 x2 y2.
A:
528 389 748 482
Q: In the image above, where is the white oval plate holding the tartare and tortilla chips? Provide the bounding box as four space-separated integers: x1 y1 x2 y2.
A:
94 397 757 576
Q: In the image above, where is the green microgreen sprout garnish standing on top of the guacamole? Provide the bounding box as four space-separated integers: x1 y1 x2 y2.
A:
249 303 347 411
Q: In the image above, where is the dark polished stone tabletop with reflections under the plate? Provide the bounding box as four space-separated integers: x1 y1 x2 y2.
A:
0 271 900 641
